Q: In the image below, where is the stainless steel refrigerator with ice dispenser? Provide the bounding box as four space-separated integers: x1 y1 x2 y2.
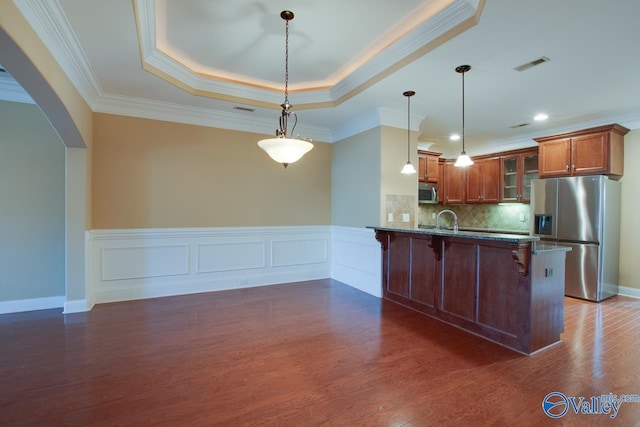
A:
531 175 620 302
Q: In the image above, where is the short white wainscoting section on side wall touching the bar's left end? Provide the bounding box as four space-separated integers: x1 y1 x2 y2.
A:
331 226 382 298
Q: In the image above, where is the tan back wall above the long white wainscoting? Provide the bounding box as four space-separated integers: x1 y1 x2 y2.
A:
92 114 331 229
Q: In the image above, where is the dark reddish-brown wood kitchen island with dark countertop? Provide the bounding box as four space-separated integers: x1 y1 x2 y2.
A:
368 227 570 355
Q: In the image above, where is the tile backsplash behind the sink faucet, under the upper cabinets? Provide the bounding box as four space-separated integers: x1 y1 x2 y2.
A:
418 203 531 233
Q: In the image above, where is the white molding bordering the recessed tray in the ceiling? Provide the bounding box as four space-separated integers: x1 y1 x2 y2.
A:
134 0 484 110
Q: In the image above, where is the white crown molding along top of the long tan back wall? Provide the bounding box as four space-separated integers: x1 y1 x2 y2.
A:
94 95 333 142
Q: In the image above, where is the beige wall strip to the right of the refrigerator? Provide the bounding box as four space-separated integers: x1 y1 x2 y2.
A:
620 129 640 289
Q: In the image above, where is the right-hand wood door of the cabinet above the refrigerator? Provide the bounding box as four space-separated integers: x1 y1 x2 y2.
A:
571 132 609 175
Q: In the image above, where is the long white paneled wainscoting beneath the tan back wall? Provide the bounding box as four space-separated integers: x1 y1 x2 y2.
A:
87 226 331 303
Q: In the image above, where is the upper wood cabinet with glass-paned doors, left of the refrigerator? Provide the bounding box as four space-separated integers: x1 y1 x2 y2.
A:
500 149 538 202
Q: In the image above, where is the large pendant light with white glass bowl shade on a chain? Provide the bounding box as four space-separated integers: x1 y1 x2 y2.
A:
258 10 313 168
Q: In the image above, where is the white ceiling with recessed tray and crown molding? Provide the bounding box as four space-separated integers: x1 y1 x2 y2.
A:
0 0 640 156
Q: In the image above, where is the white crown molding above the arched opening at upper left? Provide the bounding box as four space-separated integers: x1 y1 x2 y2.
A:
14 0 103 106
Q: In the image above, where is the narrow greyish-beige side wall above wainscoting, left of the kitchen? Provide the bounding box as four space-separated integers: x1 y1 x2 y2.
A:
331 128 380 227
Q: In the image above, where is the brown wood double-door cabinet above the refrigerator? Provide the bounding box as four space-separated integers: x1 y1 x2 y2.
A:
534 124 629 178
